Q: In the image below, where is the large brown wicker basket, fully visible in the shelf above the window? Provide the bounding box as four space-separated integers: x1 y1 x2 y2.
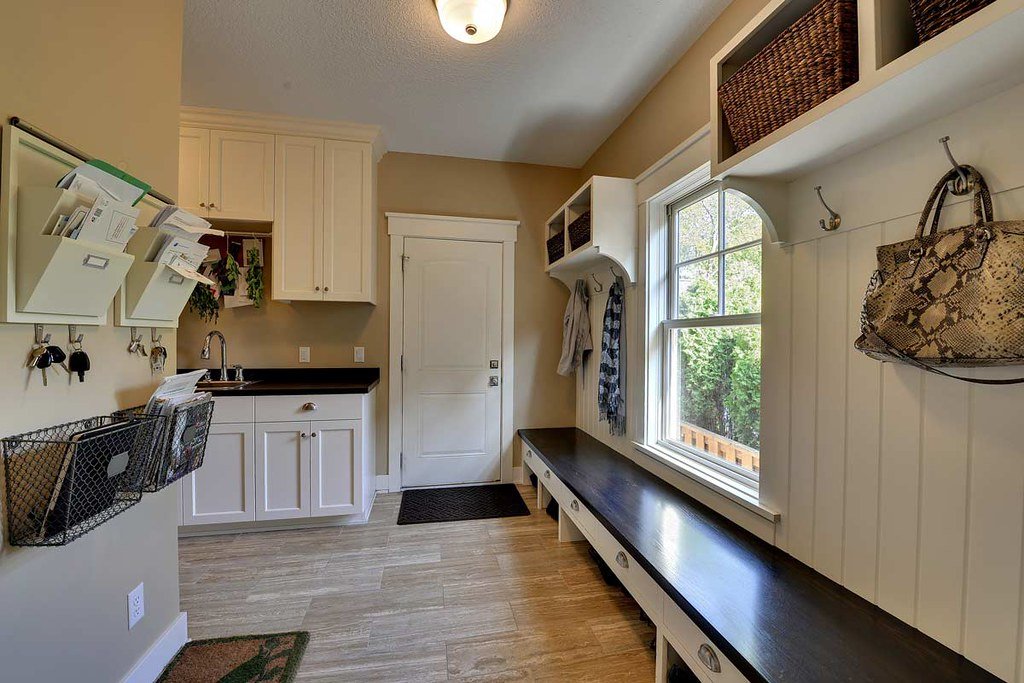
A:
718 0 857 152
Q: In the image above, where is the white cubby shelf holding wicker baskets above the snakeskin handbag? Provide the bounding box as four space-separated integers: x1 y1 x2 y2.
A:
711 0 1024 180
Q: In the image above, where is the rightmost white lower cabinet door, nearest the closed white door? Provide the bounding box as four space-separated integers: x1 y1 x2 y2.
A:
310 420 362 517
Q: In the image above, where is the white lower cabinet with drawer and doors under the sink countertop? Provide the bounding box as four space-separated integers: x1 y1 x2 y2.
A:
180 392 376 530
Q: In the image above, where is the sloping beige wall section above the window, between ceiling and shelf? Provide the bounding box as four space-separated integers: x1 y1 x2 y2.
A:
582 0 768 178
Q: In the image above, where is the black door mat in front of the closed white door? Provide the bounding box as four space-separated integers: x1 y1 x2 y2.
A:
398 483 529 524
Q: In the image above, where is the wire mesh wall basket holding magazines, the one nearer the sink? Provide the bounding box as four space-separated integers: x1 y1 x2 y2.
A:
114 398 213 494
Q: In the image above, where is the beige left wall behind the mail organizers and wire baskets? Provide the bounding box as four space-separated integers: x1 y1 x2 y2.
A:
0 0 182 683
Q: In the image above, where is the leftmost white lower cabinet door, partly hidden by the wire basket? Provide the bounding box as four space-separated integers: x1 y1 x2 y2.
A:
181 423 256 526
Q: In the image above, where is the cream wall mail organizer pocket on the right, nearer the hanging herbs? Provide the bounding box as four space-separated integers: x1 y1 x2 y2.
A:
124 227 196 321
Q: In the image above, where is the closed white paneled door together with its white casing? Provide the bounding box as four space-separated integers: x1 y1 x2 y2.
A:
386 213 519 490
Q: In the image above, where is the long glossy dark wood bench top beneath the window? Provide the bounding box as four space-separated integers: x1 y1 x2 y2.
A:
519 428 999 683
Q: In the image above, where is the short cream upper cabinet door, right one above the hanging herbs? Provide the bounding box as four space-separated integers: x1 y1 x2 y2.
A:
208 130 273 220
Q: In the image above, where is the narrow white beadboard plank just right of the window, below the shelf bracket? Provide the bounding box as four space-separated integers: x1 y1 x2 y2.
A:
782 242 818 566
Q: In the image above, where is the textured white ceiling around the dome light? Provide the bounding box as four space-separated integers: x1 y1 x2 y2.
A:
182 0 729 167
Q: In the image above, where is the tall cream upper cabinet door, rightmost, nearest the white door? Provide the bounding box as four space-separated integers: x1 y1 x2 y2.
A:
324 140 377 302
